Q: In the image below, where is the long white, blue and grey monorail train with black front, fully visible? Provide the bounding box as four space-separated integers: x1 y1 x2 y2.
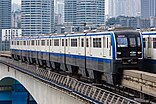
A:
11 30 143 84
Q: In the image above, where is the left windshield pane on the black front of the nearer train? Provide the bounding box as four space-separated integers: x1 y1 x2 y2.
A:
117 36 128 47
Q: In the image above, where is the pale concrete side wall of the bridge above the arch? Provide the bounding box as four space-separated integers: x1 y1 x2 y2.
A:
0 63 85 104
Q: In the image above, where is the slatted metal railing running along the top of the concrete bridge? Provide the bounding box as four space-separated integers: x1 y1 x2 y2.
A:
0 57 139 104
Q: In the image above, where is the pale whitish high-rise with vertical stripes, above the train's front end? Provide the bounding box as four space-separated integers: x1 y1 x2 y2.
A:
105 0 141 18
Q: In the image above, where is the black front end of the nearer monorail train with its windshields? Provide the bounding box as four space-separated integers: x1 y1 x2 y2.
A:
113 31 143 83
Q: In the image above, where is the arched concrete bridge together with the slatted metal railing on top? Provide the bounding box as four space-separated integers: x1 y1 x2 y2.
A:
0 55 139 104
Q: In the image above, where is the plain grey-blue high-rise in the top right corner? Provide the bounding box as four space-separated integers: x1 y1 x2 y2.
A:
141 0 156 18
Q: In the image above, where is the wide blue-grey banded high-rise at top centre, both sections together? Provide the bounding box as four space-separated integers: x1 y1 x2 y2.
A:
64 0 105 27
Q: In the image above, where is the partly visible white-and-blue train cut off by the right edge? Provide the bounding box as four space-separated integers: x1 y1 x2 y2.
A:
142 31 156 73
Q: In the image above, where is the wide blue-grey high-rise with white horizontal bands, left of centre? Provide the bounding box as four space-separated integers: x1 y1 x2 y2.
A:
21 0 54 36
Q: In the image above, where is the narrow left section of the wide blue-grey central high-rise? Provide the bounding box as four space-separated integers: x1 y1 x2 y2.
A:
64 0 78 25
